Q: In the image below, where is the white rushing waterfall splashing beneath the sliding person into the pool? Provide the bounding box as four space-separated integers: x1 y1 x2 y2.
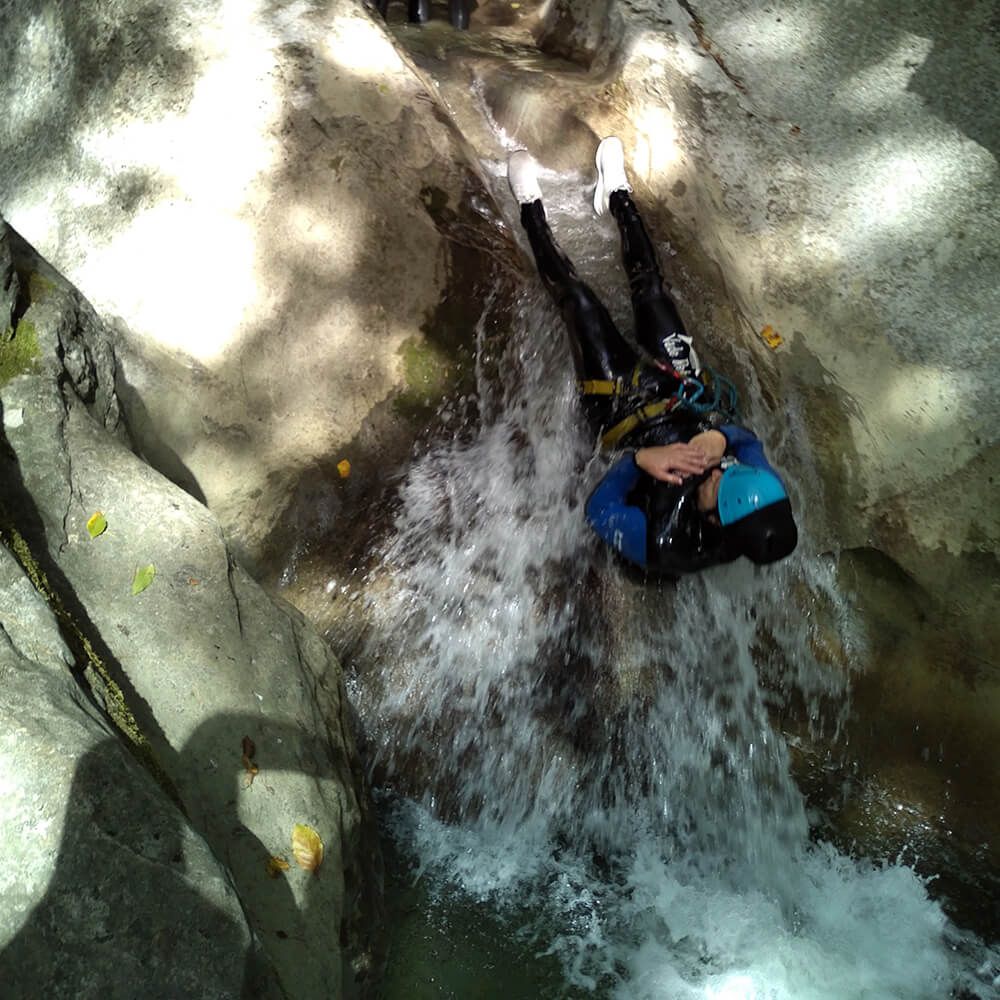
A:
340 168 997 1000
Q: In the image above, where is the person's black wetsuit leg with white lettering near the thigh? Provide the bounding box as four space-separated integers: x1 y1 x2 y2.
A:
609 191 696 375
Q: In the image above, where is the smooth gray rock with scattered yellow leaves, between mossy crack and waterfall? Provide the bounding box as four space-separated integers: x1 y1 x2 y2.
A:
0 223 380 998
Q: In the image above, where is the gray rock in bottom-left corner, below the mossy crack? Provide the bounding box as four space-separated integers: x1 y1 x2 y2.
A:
0 547 266 1000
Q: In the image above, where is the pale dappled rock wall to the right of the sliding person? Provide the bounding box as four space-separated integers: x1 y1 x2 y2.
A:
312 2 1000 937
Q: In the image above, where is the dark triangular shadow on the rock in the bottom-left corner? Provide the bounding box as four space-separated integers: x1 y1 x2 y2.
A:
0 739 281 1000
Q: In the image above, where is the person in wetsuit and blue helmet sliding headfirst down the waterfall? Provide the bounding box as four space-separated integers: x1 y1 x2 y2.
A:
507 142 798 576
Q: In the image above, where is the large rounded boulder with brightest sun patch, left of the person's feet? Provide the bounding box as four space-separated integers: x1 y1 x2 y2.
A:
0 0 508 567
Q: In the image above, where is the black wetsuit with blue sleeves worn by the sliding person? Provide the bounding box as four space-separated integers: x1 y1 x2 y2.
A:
521 191 774 575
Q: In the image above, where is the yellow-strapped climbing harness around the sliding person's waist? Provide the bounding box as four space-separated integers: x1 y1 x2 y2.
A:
579 365 739 448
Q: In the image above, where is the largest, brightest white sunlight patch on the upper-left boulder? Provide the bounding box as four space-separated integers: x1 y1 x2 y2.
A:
10 2 280 362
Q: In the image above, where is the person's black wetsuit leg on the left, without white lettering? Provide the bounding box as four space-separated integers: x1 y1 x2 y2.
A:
521 201 638 379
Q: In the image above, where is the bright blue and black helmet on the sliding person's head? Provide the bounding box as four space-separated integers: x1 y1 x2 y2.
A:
718 464 799 563
